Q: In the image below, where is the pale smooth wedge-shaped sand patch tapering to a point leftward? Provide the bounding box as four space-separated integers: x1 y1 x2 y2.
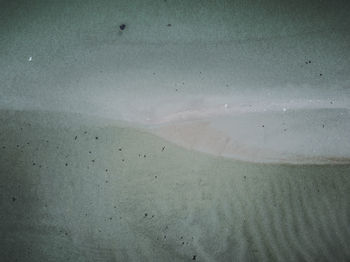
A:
151 108 350 164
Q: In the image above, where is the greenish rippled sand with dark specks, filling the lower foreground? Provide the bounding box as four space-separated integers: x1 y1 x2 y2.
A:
0 111 350 262
